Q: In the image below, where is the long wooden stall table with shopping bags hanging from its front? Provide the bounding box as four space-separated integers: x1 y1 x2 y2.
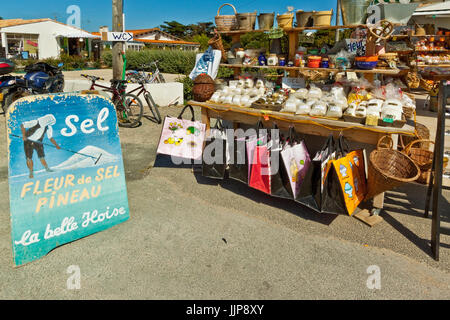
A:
188 101 415 214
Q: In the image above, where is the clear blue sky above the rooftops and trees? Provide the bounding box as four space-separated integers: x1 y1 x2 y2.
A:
0 0 336 31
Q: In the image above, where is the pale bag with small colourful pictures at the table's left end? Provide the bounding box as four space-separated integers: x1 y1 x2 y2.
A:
157 105 206 161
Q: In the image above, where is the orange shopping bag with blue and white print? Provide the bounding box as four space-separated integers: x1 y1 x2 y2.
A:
333 136 366 216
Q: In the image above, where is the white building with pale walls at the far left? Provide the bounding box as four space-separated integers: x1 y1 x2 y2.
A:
0 19 99 59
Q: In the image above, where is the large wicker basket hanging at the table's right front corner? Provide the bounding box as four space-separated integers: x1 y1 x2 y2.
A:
365 136 420 200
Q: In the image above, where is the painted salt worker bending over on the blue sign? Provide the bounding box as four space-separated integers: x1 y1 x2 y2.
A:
20 114 61 179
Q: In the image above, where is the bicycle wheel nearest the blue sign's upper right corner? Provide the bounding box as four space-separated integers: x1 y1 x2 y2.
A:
115 93 144 128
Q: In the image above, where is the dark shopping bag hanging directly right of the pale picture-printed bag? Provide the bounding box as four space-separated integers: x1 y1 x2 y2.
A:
202 119 227 179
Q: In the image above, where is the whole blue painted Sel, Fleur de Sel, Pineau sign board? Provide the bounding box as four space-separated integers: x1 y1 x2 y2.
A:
7 94 130 266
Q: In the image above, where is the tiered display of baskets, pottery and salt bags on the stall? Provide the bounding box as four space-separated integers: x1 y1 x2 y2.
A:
208 4 415 128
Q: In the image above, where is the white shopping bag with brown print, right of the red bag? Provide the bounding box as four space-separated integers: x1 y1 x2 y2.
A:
281 128 311 199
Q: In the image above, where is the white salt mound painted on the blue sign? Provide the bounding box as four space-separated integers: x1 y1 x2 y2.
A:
52 146 119 170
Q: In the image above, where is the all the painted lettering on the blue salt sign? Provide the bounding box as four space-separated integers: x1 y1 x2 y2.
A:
15 109 126 246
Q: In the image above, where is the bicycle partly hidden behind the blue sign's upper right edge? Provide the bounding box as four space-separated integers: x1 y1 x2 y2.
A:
81 74 144 128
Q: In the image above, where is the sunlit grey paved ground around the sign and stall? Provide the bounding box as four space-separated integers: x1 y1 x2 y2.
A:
0 102 450 299
